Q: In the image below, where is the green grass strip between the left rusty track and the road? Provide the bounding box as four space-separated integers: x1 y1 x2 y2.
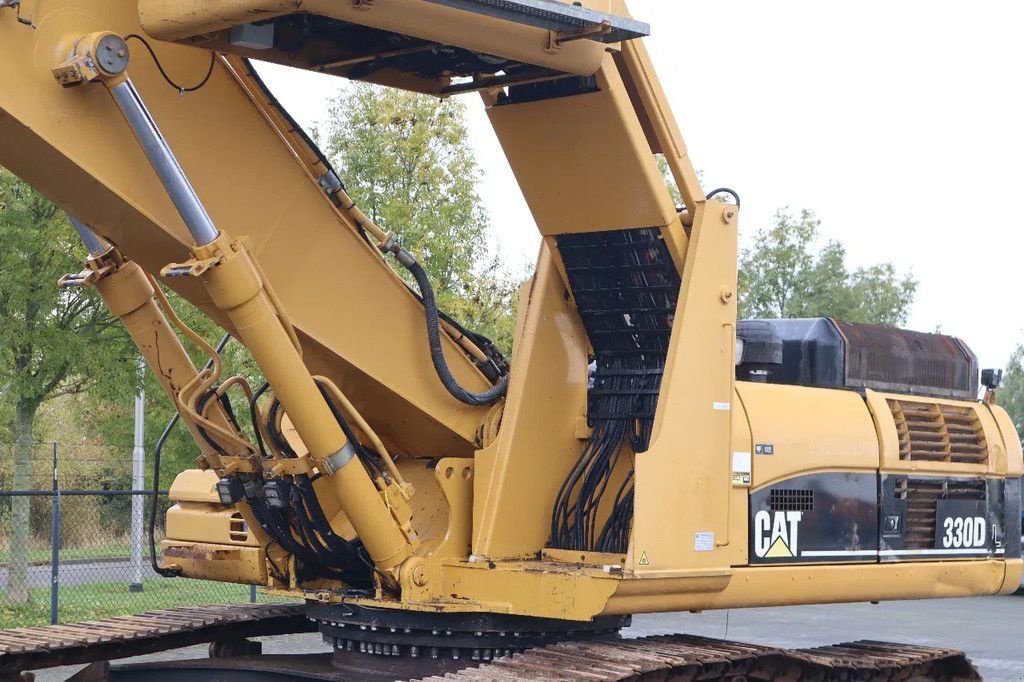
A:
0 578 296 630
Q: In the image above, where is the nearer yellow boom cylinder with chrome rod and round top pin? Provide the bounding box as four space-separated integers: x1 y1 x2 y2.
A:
54 32 416 577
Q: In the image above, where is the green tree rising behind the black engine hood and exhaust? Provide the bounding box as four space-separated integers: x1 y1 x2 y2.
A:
739 209 918 326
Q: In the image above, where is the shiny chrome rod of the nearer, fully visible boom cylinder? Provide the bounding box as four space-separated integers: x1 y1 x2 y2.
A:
111 79 219 246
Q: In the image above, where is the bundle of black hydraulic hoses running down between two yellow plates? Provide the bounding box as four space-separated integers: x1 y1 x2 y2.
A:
551 228 680 553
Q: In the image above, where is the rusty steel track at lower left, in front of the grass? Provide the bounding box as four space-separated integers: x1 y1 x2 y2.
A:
0 603 316 679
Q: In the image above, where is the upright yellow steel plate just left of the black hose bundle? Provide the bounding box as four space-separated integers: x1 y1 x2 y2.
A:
473 242 589 558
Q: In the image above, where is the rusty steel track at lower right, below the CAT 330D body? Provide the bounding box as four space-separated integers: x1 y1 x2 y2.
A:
422 635 981 682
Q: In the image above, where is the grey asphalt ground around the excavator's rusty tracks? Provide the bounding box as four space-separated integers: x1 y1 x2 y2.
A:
36 596 1024 682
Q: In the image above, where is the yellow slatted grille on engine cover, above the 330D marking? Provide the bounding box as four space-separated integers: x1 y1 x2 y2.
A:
889 399 988 464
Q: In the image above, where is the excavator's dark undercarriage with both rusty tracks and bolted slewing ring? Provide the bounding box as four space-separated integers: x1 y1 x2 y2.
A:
0 603 981 682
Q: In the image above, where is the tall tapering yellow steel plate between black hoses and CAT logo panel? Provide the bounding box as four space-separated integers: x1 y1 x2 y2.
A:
629 202 746 579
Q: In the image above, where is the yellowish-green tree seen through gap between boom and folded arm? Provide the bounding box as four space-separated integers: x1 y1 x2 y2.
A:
326 84 518 351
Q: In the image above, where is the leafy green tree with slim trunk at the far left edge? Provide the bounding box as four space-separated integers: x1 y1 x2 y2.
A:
0 169 135 603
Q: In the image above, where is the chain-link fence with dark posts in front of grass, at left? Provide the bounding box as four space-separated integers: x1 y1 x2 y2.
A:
0 443 278 629
